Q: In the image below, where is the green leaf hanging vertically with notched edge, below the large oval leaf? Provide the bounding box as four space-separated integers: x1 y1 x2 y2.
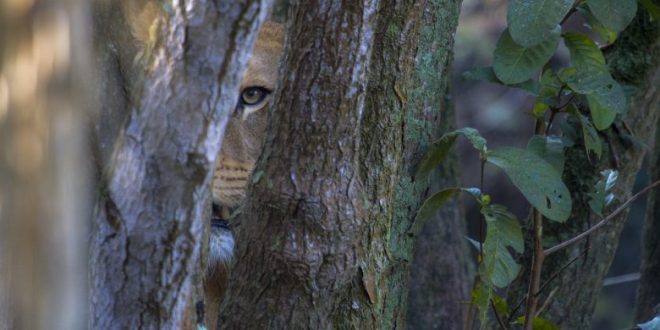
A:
481 205 524 288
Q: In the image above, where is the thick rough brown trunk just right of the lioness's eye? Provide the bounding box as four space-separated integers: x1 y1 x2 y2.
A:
221 0 458 329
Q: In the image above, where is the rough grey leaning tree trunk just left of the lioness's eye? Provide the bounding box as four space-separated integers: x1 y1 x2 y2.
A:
90 0 271 329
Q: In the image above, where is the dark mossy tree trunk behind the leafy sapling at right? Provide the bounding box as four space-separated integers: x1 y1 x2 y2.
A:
510 8 660 329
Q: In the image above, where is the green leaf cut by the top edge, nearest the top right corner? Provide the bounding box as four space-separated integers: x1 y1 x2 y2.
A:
587 0 637 32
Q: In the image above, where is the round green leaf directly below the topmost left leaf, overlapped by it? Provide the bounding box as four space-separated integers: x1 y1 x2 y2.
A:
493 26 561 84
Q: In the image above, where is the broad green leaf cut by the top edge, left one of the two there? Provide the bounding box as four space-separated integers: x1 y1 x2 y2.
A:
507 0 575 47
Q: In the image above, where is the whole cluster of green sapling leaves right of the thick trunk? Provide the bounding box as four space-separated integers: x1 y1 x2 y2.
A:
415 0 648 329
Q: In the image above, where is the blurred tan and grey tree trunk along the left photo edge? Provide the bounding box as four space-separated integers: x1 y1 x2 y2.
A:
0 0 91 330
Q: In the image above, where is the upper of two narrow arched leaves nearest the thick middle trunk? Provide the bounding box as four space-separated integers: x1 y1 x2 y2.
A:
415 127 486 180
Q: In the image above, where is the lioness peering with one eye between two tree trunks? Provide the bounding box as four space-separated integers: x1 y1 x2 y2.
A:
122 0 284 329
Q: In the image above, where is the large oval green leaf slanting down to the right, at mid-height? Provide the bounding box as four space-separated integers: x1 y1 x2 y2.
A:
487 148 571 222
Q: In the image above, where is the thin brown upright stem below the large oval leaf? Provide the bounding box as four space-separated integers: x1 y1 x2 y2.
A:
523 209 545 330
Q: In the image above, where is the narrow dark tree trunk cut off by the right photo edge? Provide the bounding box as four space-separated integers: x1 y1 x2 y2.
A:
635 108 660 322
